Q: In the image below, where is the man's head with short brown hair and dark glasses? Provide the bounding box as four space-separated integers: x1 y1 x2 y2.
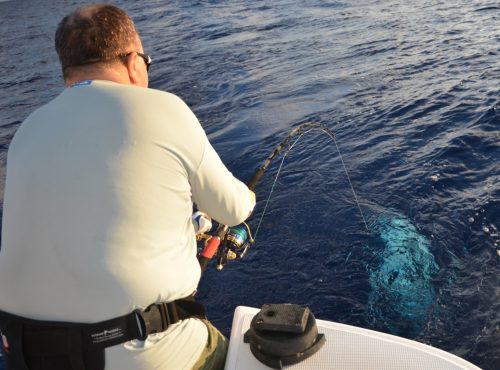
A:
55 4 148 86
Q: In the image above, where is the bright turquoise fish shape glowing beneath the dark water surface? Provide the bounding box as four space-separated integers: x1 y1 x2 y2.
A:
367 214 439 338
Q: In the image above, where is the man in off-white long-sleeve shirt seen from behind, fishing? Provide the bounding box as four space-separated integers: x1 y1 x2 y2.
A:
0 4 255 370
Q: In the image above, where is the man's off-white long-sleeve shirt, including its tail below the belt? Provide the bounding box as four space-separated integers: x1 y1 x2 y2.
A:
0 81 254 370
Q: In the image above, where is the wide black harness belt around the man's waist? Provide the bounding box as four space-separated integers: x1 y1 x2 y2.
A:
0 297 206 370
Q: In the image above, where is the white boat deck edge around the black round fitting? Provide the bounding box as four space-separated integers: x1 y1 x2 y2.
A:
225 306 481 370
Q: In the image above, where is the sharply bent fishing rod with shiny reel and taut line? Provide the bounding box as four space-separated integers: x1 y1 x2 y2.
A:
197 122 368 271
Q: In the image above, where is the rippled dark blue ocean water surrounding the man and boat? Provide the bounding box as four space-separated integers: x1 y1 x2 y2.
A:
0 0 500 369
